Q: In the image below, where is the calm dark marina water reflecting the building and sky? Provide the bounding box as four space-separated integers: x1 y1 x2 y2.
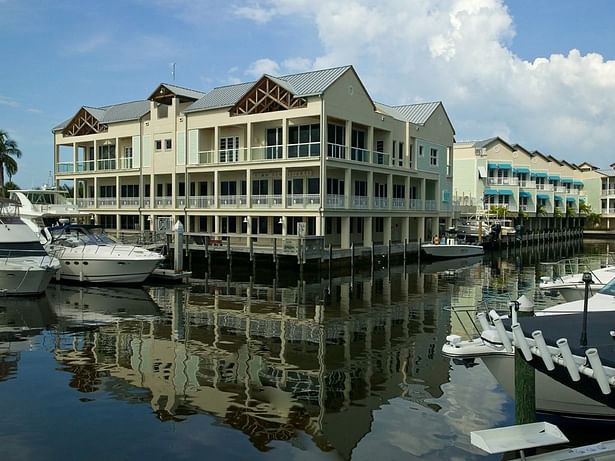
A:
0 242 607 460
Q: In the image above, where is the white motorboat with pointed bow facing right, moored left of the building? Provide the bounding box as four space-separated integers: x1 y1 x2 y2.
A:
43 224 164 283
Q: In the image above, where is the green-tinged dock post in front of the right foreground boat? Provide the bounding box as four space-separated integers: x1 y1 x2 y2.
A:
511 301 536 424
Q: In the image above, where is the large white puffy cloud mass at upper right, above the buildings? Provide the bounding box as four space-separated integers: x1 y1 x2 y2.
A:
238 0 615 166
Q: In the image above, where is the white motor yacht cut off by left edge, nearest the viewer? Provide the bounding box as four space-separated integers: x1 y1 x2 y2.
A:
0 199 60 295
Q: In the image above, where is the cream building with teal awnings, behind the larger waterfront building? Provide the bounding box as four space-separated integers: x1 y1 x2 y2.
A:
453 137 615 227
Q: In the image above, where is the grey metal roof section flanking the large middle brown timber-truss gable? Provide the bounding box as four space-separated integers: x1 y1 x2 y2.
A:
184 66 352 112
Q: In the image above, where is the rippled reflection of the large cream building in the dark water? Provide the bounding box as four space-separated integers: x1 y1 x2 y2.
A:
20 255 548 459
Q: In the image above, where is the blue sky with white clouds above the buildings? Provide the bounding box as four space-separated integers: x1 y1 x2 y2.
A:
0 0 615 188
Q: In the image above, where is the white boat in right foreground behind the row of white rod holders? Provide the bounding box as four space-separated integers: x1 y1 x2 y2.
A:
442 279 615 420
